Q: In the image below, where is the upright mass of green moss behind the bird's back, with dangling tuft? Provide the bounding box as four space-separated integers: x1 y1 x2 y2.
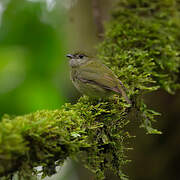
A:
99 0 180 134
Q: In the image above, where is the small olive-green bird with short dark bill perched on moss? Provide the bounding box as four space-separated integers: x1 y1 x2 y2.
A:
66 53 132 104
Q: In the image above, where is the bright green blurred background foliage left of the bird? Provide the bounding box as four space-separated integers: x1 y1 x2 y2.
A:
0 0 66 116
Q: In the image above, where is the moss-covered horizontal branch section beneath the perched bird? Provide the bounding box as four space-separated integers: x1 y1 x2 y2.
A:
0 96 130 179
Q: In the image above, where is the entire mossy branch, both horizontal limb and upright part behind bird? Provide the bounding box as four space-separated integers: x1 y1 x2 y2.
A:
0 0 180 179
